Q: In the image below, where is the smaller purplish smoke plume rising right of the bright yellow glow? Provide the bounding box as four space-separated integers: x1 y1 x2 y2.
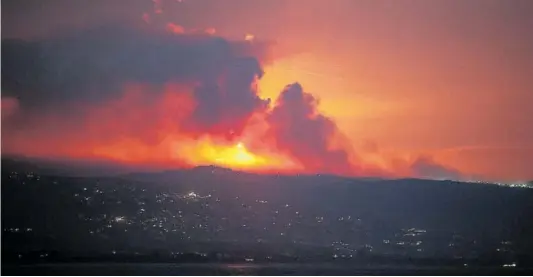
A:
267 83 353 173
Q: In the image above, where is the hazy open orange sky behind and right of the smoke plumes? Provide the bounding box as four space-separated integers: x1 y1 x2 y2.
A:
2 0 533 180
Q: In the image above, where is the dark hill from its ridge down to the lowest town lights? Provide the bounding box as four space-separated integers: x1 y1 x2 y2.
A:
1 155 533 264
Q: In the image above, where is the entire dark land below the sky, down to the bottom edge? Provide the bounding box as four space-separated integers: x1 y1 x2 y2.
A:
1 157 533 275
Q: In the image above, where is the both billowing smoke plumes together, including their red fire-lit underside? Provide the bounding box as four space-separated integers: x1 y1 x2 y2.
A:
2 20 462 178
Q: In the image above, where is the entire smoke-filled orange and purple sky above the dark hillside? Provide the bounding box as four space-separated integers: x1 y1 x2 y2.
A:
2 0 533 181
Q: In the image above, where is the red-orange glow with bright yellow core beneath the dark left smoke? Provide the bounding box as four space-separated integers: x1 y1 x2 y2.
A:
4 81 304 172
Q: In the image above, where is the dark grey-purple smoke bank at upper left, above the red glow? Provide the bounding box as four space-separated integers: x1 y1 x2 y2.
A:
2 24 269 135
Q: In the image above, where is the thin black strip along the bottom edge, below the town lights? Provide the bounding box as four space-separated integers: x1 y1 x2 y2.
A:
2 263 533 276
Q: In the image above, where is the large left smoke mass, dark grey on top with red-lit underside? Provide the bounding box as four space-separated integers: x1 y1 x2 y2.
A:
2 22 282 167
